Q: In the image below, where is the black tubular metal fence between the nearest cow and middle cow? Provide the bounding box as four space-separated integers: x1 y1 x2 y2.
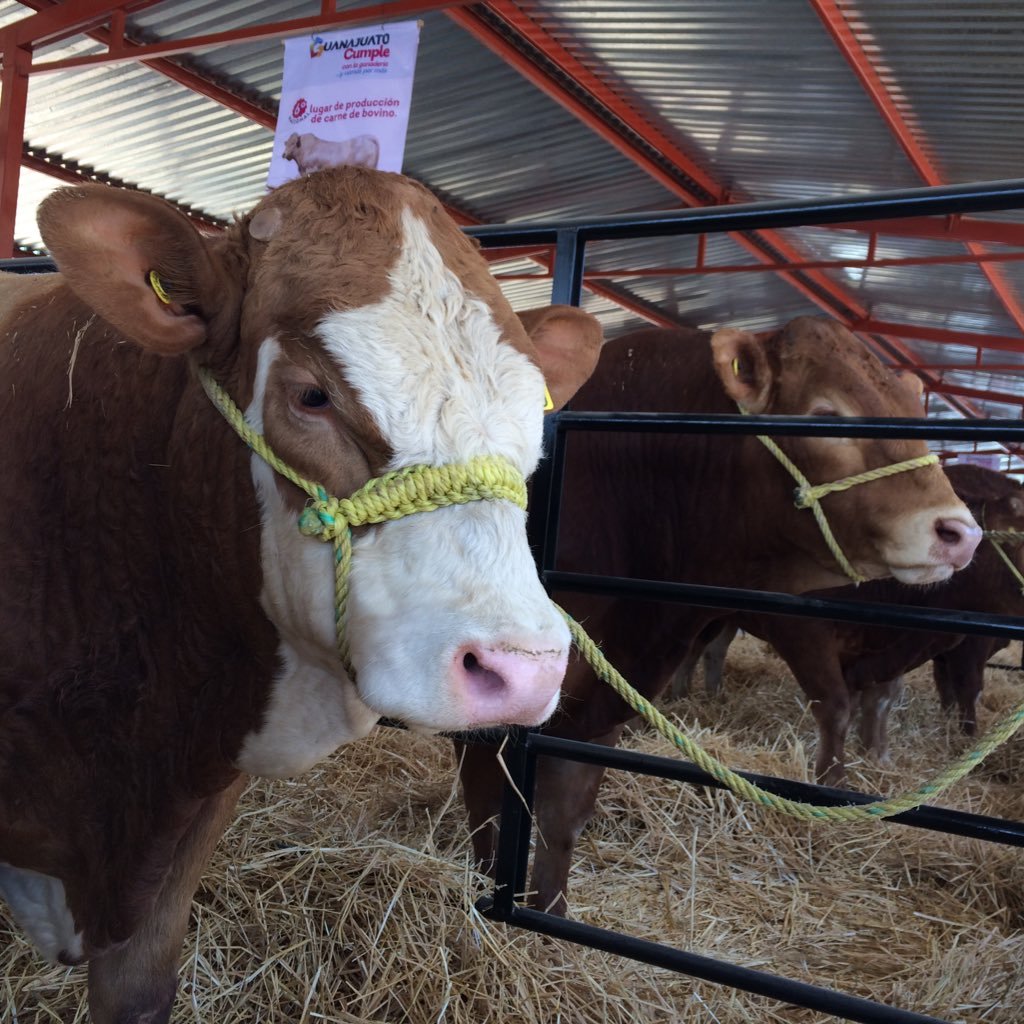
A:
468 180 1024 1024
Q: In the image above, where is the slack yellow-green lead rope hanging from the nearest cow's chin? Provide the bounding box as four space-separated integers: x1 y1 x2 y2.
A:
559 609 1024 822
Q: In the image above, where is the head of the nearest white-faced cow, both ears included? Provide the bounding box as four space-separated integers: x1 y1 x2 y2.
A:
39 174 601 774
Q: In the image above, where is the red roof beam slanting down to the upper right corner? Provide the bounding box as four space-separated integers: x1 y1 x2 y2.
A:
810 0 1024 339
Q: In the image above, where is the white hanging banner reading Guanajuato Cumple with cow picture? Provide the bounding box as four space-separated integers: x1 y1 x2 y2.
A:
266 22 420 188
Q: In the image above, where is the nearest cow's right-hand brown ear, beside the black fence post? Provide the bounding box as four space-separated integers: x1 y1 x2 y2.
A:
517 306 604 412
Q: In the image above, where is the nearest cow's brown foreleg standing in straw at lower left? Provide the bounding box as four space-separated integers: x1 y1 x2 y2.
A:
89 776 245 1024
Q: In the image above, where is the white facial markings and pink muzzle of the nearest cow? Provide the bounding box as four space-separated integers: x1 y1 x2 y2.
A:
240 205 569 774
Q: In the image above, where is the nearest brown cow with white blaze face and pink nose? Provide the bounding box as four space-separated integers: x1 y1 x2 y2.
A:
0 168 600 1024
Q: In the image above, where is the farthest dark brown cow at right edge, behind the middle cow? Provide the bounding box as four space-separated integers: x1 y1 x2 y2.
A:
671 466 1024 785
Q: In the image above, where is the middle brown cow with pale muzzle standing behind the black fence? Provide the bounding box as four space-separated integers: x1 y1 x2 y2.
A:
462 317 980 910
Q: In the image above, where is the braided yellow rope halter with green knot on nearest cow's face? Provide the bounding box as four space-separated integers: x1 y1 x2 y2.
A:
198 368 526 681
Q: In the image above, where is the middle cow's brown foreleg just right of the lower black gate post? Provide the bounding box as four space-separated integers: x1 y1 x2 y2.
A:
529 725 623 915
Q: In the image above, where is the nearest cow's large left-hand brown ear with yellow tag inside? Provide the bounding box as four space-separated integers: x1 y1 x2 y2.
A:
37 185 223 355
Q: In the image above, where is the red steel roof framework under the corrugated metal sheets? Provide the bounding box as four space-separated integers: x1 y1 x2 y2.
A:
0 0 1024 415
